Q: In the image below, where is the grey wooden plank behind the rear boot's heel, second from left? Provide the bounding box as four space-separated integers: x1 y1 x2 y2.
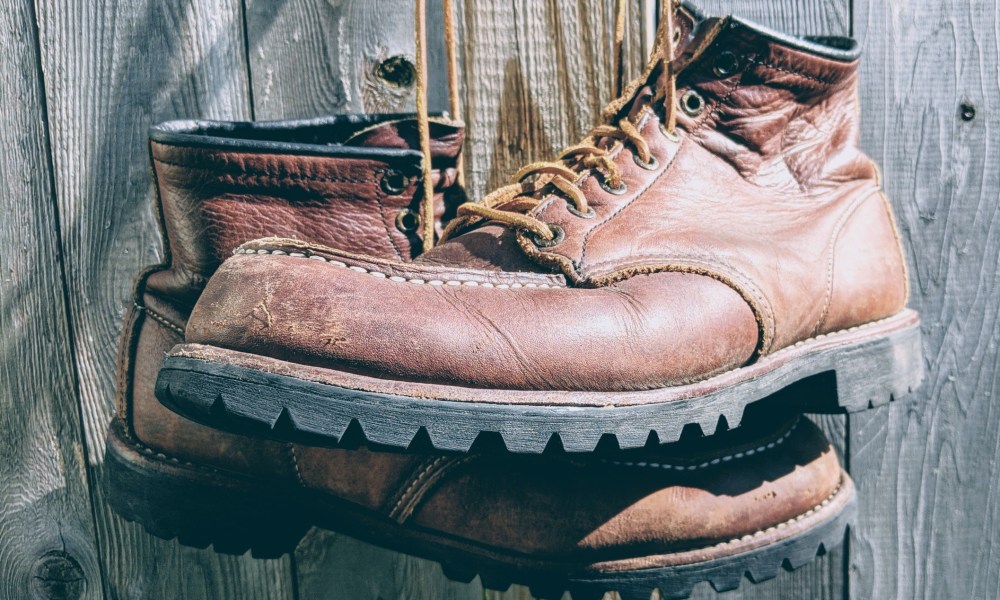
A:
36 0 294 598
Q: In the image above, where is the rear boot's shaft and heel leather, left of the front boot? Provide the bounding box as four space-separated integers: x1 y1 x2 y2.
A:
108 111 464 482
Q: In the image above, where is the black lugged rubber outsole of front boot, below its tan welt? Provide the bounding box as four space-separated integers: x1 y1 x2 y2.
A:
156 316 923 453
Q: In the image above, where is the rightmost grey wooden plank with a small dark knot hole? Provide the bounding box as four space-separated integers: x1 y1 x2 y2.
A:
850 0 1000 598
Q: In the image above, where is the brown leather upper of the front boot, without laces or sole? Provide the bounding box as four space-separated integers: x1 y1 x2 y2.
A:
188 19 907 391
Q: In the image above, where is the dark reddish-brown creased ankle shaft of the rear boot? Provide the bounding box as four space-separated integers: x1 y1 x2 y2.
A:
149 119 463 307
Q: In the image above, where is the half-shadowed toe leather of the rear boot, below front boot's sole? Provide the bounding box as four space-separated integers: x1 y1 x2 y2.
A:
412 420 841 561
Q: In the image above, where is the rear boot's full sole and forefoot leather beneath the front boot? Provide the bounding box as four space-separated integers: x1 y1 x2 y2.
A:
106 406 855 600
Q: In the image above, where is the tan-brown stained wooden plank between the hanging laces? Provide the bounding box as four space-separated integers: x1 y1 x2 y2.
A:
463 0 645 197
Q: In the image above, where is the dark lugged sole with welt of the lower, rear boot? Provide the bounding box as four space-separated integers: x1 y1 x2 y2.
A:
102 423 856 600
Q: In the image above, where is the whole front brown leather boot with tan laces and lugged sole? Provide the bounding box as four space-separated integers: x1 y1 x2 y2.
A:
159 9 923 452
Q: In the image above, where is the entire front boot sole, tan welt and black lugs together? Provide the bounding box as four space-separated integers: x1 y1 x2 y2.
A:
156 311 924 453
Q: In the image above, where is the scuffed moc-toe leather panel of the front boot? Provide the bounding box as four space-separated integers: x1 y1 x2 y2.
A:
185 253 757 390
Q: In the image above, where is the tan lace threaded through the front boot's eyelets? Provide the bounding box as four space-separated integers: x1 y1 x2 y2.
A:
442 0 677 241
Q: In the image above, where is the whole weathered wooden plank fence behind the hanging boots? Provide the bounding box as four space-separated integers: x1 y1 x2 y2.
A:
0 0 1000 600
